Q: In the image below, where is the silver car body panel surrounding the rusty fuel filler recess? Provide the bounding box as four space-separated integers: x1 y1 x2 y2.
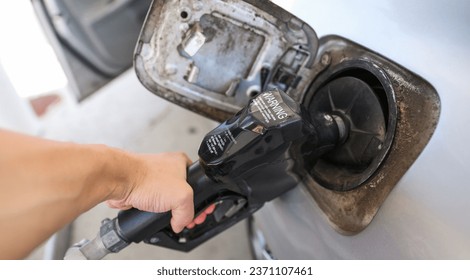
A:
255 0 470 259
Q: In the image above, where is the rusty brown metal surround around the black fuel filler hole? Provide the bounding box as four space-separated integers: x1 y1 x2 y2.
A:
303 36 440 234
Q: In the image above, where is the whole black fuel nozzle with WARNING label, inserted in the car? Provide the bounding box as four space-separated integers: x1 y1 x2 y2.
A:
64 90 347 260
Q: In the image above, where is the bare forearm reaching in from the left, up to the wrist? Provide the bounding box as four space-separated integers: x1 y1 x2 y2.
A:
0 130 141 258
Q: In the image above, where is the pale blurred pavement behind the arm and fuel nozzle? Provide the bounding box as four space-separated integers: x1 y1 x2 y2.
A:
28 70 252 260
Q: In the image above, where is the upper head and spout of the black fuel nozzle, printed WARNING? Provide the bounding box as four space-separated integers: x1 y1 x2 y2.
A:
199 89 347 181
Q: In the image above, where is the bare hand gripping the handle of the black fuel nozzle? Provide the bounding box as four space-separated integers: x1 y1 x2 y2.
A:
107 153 194 233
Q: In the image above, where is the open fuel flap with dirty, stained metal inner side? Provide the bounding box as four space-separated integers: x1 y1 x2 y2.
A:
135 0 318 121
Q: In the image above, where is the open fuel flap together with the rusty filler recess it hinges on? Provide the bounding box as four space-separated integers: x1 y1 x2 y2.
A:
134 0 440 234
